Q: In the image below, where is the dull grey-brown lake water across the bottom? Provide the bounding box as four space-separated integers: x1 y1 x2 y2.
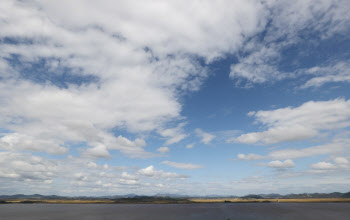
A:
0 203 350 220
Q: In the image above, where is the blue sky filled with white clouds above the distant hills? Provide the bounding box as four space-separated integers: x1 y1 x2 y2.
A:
0 0 350 196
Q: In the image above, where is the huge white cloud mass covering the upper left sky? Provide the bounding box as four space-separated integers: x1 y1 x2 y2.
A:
0 1 266 160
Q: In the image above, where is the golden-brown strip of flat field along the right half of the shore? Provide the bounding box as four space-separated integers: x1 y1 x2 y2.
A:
189 198 350 203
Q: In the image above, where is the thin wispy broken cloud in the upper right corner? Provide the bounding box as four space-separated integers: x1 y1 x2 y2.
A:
230 0 350 87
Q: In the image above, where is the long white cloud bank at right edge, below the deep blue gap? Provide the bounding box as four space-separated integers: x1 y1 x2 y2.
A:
231 99 350 144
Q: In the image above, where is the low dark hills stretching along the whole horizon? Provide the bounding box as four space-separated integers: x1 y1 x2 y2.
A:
0 192 350 200
